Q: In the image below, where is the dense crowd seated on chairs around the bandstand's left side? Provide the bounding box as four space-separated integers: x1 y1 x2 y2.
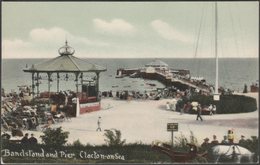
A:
1 86 75 139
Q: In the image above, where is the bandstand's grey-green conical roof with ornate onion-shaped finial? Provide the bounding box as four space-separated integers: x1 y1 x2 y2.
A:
23 41 107 72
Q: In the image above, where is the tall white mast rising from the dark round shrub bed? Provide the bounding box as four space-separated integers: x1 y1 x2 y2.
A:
214 1 219 100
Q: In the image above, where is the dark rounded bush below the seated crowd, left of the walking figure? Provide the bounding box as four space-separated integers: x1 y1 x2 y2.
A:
40 127 69 147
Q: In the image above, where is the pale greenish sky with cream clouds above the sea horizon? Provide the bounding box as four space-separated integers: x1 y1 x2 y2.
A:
2 1 259 58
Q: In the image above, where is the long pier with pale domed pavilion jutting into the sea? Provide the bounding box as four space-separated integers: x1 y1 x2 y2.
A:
116 60 211 94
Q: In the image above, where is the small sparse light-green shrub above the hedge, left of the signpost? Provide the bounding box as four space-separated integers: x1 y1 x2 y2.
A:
104 129 126 146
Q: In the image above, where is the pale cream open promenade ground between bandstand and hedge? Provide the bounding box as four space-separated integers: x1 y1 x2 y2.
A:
10 93 259 145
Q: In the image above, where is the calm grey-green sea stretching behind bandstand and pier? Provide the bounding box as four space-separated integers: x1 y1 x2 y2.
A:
1 58 259 92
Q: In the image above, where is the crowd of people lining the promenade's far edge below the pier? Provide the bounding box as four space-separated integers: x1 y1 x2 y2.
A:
101 87 216 118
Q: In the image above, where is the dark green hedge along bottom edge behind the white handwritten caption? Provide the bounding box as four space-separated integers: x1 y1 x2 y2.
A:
2 143 171 163
